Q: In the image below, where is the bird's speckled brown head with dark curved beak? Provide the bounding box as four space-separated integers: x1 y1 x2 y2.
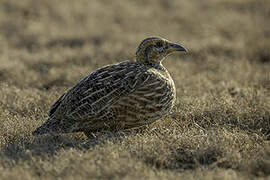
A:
136 37 187 64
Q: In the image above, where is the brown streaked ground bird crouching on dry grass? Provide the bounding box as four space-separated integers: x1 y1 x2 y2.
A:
33 37 187 137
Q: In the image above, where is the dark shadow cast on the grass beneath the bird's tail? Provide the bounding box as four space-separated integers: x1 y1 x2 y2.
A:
0 133 129 162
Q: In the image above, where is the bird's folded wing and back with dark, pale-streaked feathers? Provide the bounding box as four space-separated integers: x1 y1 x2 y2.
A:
52 62 148 121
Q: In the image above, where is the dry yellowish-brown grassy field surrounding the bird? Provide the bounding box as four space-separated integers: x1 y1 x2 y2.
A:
0 0 270 180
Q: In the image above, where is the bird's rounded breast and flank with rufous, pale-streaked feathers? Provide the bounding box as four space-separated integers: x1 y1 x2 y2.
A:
112 68 176 126
